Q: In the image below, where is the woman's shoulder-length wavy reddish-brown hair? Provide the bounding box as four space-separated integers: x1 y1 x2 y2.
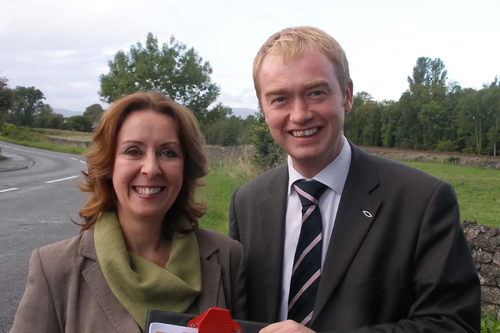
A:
78 92 208 233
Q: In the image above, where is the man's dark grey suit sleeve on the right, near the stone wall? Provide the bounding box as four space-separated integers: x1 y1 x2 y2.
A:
322 182 481 333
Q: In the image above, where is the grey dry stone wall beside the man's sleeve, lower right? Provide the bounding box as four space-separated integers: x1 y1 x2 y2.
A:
462 221 500 318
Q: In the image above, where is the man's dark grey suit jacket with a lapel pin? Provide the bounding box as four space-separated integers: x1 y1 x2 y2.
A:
229 144 481 333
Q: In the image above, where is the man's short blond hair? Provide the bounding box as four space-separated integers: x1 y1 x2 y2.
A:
253 26 351 104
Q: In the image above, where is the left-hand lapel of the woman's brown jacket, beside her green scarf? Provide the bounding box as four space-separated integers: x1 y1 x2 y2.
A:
80 229 141 333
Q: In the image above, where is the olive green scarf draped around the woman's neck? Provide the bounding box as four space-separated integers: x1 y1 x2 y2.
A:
94 212 201 332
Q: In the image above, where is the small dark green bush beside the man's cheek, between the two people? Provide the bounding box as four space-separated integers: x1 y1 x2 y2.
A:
250 114 286 170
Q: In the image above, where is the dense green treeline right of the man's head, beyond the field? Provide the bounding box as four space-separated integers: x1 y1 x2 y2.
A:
345 57 500 156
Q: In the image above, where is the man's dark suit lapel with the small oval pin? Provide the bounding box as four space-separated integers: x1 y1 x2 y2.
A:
312 145 381 322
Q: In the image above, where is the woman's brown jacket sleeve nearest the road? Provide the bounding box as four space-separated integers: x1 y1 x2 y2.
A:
10 249 61 333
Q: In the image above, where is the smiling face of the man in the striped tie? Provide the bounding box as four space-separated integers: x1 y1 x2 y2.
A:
259 49 352 178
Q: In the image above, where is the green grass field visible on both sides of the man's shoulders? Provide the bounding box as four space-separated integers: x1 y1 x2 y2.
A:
197 159 500 234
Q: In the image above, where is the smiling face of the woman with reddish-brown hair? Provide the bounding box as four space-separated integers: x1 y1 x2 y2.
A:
112 110 184 222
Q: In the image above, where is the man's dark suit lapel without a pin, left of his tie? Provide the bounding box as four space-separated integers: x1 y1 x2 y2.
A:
255 165 288 322
